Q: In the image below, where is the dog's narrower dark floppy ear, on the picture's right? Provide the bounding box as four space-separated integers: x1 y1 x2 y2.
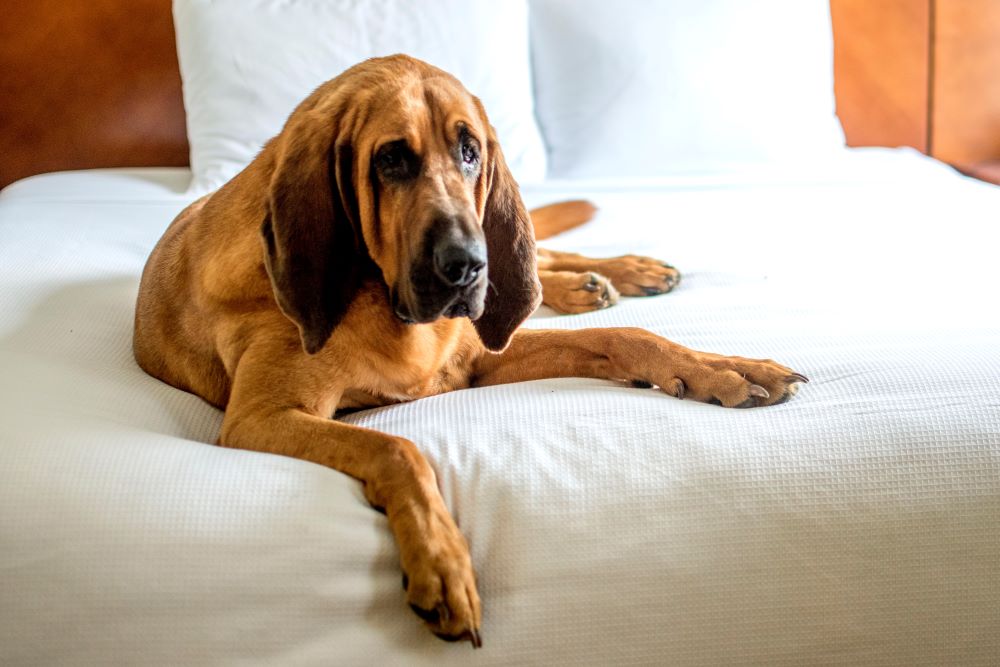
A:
474 130 542 352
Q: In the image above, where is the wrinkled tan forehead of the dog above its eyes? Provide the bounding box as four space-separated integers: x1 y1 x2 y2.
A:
366 77 486 153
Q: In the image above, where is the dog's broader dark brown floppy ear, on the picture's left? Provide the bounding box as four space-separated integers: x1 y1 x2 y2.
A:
261 110 363 354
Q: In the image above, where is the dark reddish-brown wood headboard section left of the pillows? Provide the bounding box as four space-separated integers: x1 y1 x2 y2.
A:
0 0 188 187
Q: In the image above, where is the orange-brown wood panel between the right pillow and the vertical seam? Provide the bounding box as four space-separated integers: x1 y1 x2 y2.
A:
830 0 928 151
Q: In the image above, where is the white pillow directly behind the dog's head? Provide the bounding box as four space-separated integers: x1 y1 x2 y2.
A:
174 0 545 193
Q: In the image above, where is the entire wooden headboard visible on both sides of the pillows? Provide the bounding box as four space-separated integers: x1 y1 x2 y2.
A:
0 0 1000 187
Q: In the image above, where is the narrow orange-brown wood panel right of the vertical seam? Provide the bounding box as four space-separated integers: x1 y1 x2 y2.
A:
931 0 1000 165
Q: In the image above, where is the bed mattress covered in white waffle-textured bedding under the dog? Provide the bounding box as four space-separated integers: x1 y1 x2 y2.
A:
0 151 1000 665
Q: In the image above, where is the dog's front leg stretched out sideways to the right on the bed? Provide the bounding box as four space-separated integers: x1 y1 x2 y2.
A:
473 328 808 408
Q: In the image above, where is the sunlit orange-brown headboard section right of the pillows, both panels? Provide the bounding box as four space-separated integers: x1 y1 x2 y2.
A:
831 0 1000 170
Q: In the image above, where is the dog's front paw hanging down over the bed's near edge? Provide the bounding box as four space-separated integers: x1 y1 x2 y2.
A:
399 510 482 648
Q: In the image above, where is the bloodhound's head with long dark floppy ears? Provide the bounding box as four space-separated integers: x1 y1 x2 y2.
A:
262 56 540 354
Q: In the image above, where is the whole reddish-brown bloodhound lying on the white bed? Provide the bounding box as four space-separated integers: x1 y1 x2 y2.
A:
134 56 806 647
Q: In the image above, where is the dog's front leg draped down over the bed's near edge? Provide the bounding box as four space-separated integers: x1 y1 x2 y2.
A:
219 368 482 648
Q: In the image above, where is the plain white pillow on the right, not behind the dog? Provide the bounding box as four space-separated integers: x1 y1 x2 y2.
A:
530 0 844 178
